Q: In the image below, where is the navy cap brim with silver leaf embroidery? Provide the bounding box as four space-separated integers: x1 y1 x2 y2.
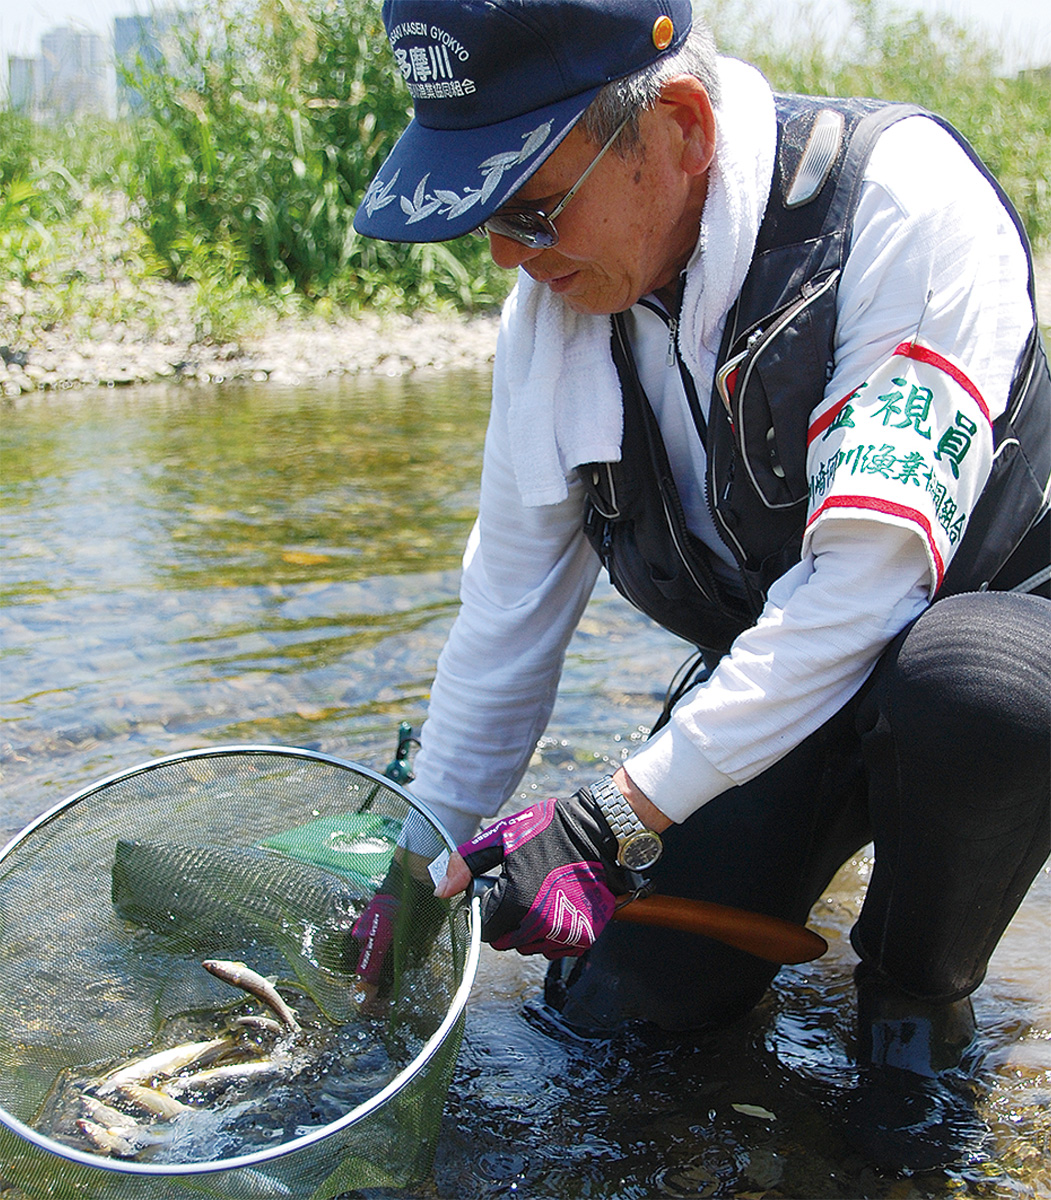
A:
354 88 601 241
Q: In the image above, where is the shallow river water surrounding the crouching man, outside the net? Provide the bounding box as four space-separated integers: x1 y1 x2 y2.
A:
0 373 1051 1200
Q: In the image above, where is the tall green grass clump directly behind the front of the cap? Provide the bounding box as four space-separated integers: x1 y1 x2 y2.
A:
130 0 503 307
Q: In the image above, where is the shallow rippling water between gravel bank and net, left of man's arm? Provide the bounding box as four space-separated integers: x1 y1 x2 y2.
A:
2 378 486 833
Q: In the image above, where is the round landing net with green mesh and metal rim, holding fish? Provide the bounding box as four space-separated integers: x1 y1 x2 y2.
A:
0 748 478 1200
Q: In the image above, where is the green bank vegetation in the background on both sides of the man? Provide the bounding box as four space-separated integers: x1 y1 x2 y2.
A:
0 0 1051 342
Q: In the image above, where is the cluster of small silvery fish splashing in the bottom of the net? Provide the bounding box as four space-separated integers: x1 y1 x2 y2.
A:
35 959 400 1163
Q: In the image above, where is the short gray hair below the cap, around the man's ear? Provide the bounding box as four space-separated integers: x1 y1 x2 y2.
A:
581 17 720 155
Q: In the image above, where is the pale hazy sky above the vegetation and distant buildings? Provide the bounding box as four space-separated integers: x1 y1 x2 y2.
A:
0 0 1051 83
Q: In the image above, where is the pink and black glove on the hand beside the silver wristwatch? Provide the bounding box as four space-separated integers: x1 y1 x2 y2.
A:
460 788 638 959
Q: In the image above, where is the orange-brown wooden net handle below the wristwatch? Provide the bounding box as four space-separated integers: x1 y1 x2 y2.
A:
613 895 828 962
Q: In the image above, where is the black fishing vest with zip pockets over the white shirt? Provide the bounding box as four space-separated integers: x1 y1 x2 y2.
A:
578 96 1051 655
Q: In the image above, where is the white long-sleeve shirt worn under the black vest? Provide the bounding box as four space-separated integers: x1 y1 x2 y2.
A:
405 84 1033 840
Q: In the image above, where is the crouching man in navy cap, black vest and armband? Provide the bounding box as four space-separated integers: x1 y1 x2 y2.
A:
355 0 1051 1132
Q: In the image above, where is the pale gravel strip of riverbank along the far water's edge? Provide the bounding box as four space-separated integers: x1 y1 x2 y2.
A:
0 242 1051 397
